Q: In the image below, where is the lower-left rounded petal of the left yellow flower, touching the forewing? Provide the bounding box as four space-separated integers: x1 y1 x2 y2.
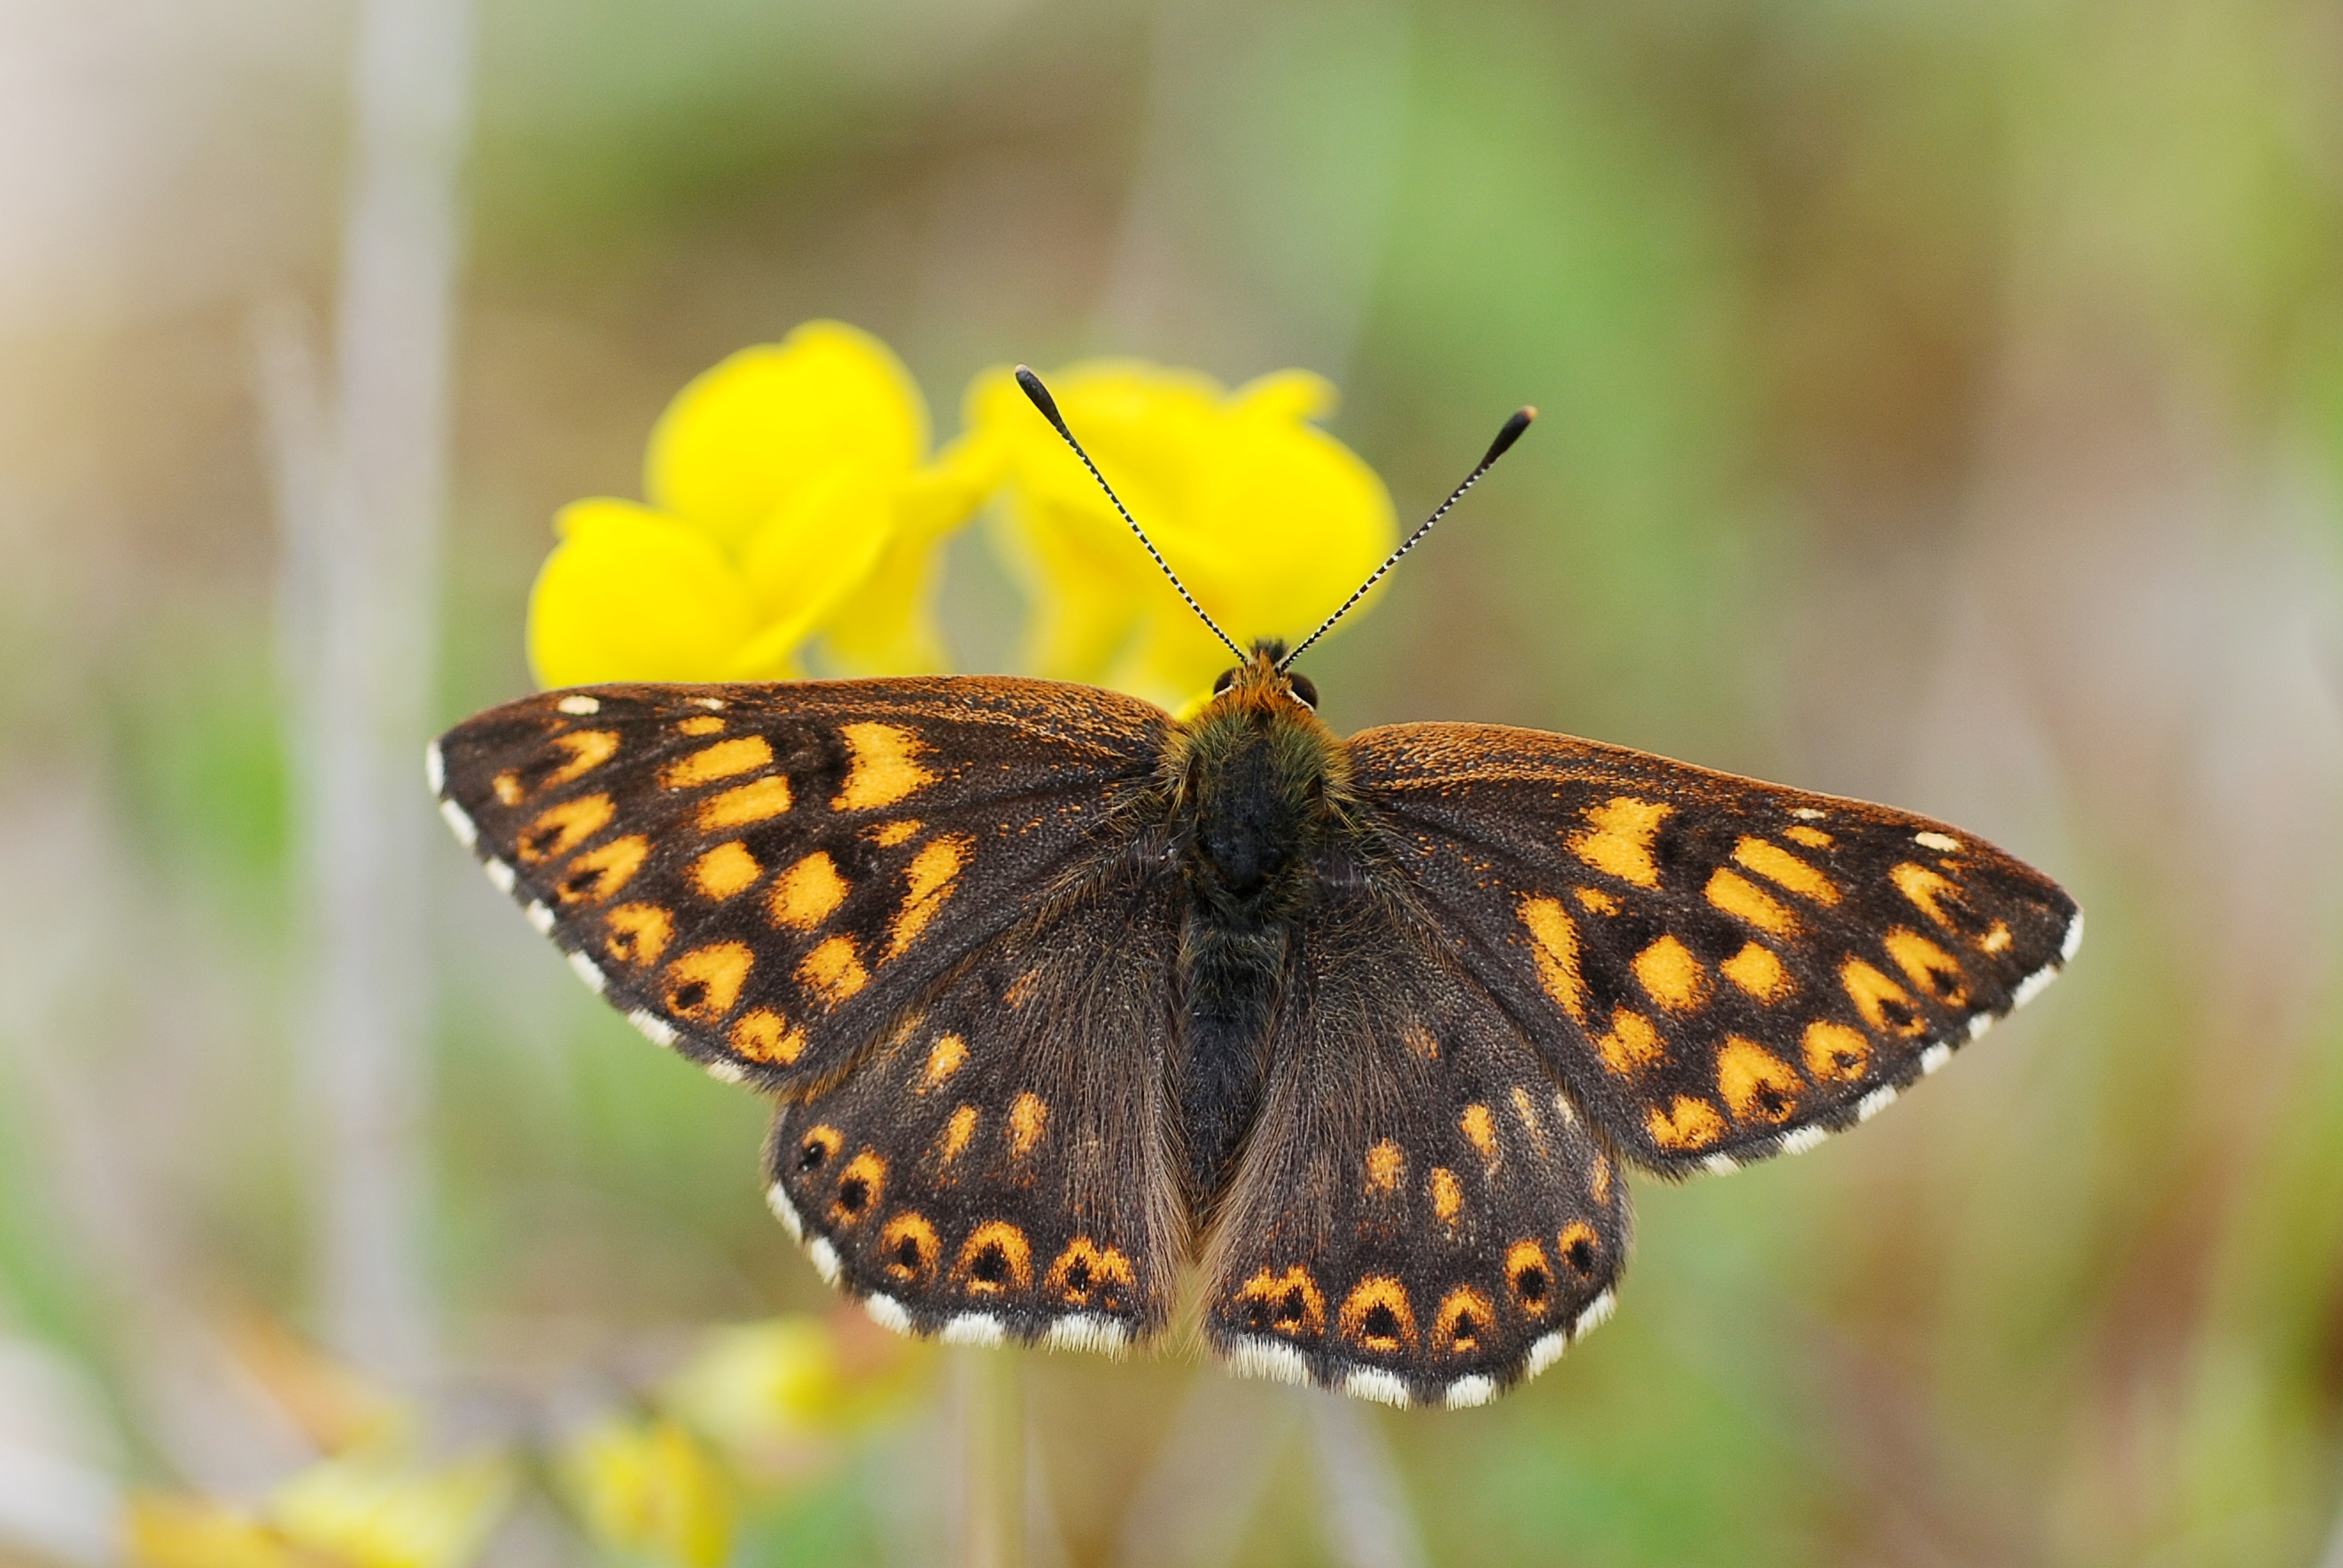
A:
530 500 759 687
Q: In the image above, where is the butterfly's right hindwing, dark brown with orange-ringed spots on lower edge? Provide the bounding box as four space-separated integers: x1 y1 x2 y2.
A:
1204 890 1629 1406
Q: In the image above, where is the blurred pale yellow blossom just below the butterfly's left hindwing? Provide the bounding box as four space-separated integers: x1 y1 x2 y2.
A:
663 1313 925 1481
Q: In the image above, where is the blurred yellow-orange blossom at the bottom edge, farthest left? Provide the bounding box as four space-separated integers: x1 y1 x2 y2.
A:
127 1439 513 1568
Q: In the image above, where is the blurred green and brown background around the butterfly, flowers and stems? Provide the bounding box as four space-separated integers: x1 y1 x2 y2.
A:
0 0 2343 1568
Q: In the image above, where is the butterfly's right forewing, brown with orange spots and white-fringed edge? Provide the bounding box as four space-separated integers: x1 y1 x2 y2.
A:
1347 725 2083 1172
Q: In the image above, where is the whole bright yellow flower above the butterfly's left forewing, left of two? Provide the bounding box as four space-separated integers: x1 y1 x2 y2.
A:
530 321 993 687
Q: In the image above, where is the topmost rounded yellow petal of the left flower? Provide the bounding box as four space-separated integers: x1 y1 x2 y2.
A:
642 321 928 546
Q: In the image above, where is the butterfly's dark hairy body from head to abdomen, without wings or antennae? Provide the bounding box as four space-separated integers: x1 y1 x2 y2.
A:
1164 647 1357 1205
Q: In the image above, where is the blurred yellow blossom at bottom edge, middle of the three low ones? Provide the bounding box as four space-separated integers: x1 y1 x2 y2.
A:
560 1418 741 1568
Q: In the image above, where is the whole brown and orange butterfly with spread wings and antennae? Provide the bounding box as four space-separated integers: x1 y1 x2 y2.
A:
429 370 2083 1406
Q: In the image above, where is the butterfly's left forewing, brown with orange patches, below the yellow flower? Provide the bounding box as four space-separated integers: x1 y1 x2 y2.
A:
431 678 1169 1090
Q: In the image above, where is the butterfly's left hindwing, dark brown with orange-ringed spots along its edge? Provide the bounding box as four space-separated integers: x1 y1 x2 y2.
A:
767 853 1183 1350
